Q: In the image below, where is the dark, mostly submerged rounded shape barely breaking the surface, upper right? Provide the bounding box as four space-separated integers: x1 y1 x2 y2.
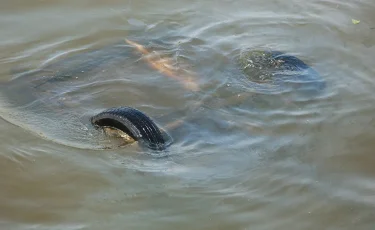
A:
238 50 326 94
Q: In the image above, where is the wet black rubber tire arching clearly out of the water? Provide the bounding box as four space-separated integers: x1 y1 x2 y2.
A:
91 107 167 150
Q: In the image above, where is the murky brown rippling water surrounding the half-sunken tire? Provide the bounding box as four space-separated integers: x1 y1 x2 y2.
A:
0 0 375 230
